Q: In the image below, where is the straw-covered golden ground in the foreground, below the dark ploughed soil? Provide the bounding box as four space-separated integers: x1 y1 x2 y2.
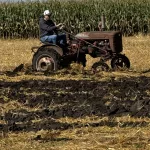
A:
0 117 150 150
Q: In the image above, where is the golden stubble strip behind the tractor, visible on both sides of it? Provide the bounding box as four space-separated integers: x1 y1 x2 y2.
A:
0 35 150 72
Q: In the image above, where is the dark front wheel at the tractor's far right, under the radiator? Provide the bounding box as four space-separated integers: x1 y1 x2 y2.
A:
111 54 130 70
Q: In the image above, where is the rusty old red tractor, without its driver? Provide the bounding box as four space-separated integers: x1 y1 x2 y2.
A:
32 31 130 72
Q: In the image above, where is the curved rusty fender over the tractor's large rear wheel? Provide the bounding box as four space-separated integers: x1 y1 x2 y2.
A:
31 44 63 56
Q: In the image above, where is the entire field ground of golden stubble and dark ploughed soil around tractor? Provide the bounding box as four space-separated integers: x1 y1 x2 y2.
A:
0 35 150 150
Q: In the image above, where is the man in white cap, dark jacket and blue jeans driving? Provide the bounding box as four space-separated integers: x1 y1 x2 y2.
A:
39 10 67 50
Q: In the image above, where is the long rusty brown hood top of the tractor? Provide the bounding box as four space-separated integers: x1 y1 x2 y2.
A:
75 31 121 40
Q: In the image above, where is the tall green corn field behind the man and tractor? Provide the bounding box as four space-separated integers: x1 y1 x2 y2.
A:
0 0 150 38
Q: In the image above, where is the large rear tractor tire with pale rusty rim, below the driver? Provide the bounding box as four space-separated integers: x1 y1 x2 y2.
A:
32 47 58 72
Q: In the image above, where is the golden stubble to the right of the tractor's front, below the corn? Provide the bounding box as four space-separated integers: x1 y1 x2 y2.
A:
123 35 150 72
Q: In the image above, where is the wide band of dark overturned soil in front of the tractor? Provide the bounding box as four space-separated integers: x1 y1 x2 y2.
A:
0 76 150 131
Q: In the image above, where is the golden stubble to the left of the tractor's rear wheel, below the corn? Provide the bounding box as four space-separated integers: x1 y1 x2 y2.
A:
0 39 40 71
